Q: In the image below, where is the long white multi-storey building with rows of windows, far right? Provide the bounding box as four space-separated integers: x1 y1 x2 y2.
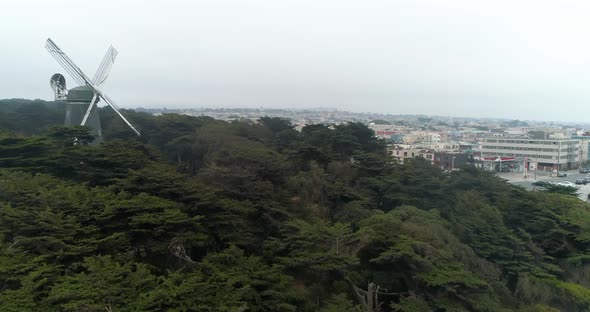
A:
481 138 581 170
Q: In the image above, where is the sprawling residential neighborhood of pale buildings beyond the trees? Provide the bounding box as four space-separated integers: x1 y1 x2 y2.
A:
138 108 590 175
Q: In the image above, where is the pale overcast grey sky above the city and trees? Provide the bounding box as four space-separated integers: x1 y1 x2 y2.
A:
0 0 590 121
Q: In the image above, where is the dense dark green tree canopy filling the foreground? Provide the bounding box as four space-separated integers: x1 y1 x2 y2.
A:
0 101 590 312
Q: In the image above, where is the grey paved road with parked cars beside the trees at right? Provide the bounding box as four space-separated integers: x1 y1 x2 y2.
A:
498 170 590 201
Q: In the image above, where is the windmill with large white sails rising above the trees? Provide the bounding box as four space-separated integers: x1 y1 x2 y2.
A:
45 38 140 143
